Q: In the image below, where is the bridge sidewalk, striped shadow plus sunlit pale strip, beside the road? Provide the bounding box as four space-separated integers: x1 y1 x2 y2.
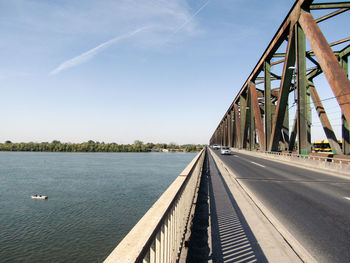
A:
207 150 313 262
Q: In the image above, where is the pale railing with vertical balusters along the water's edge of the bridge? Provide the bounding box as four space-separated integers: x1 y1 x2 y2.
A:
104 149 206 263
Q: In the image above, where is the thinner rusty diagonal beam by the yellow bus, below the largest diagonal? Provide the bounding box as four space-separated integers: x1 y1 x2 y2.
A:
309 82 341 154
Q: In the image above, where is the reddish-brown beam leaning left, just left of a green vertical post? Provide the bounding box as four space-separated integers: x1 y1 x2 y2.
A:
249 82 271 151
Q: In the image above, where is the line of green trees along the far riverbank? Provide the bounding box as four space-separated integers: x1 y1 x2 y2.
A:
0 140 204 152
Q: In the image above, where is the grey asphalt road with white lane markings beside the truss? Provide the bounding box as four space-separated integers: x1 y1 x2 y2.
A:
215 151 350 263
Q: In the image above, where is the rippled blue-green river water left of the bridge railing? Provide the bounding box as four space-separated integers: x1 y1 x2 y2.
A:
0 152 195 262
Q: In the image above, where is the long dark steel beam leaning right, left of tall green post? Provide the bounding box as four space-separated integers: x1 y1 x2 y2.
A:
269 25 295 151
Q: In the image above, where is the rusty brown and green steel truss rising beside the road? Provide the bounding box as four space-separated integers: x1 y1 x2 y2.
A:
210 0 350 154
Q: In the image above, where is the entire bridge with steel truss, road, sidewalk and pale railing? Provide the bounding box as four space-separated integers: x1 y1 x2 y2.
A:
105 0 350 262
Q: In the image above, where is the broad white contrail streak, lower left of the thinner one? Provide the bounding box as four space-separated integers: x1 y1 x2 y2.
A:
49 26 149 75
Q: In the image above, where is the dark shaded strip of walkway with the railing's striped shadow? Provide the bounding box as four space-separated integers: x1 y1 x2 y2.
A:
187 154 267 263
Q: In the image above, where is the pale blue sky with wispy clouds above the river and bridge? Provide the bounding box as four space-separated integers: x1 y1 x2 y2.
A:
0 0 349 144
